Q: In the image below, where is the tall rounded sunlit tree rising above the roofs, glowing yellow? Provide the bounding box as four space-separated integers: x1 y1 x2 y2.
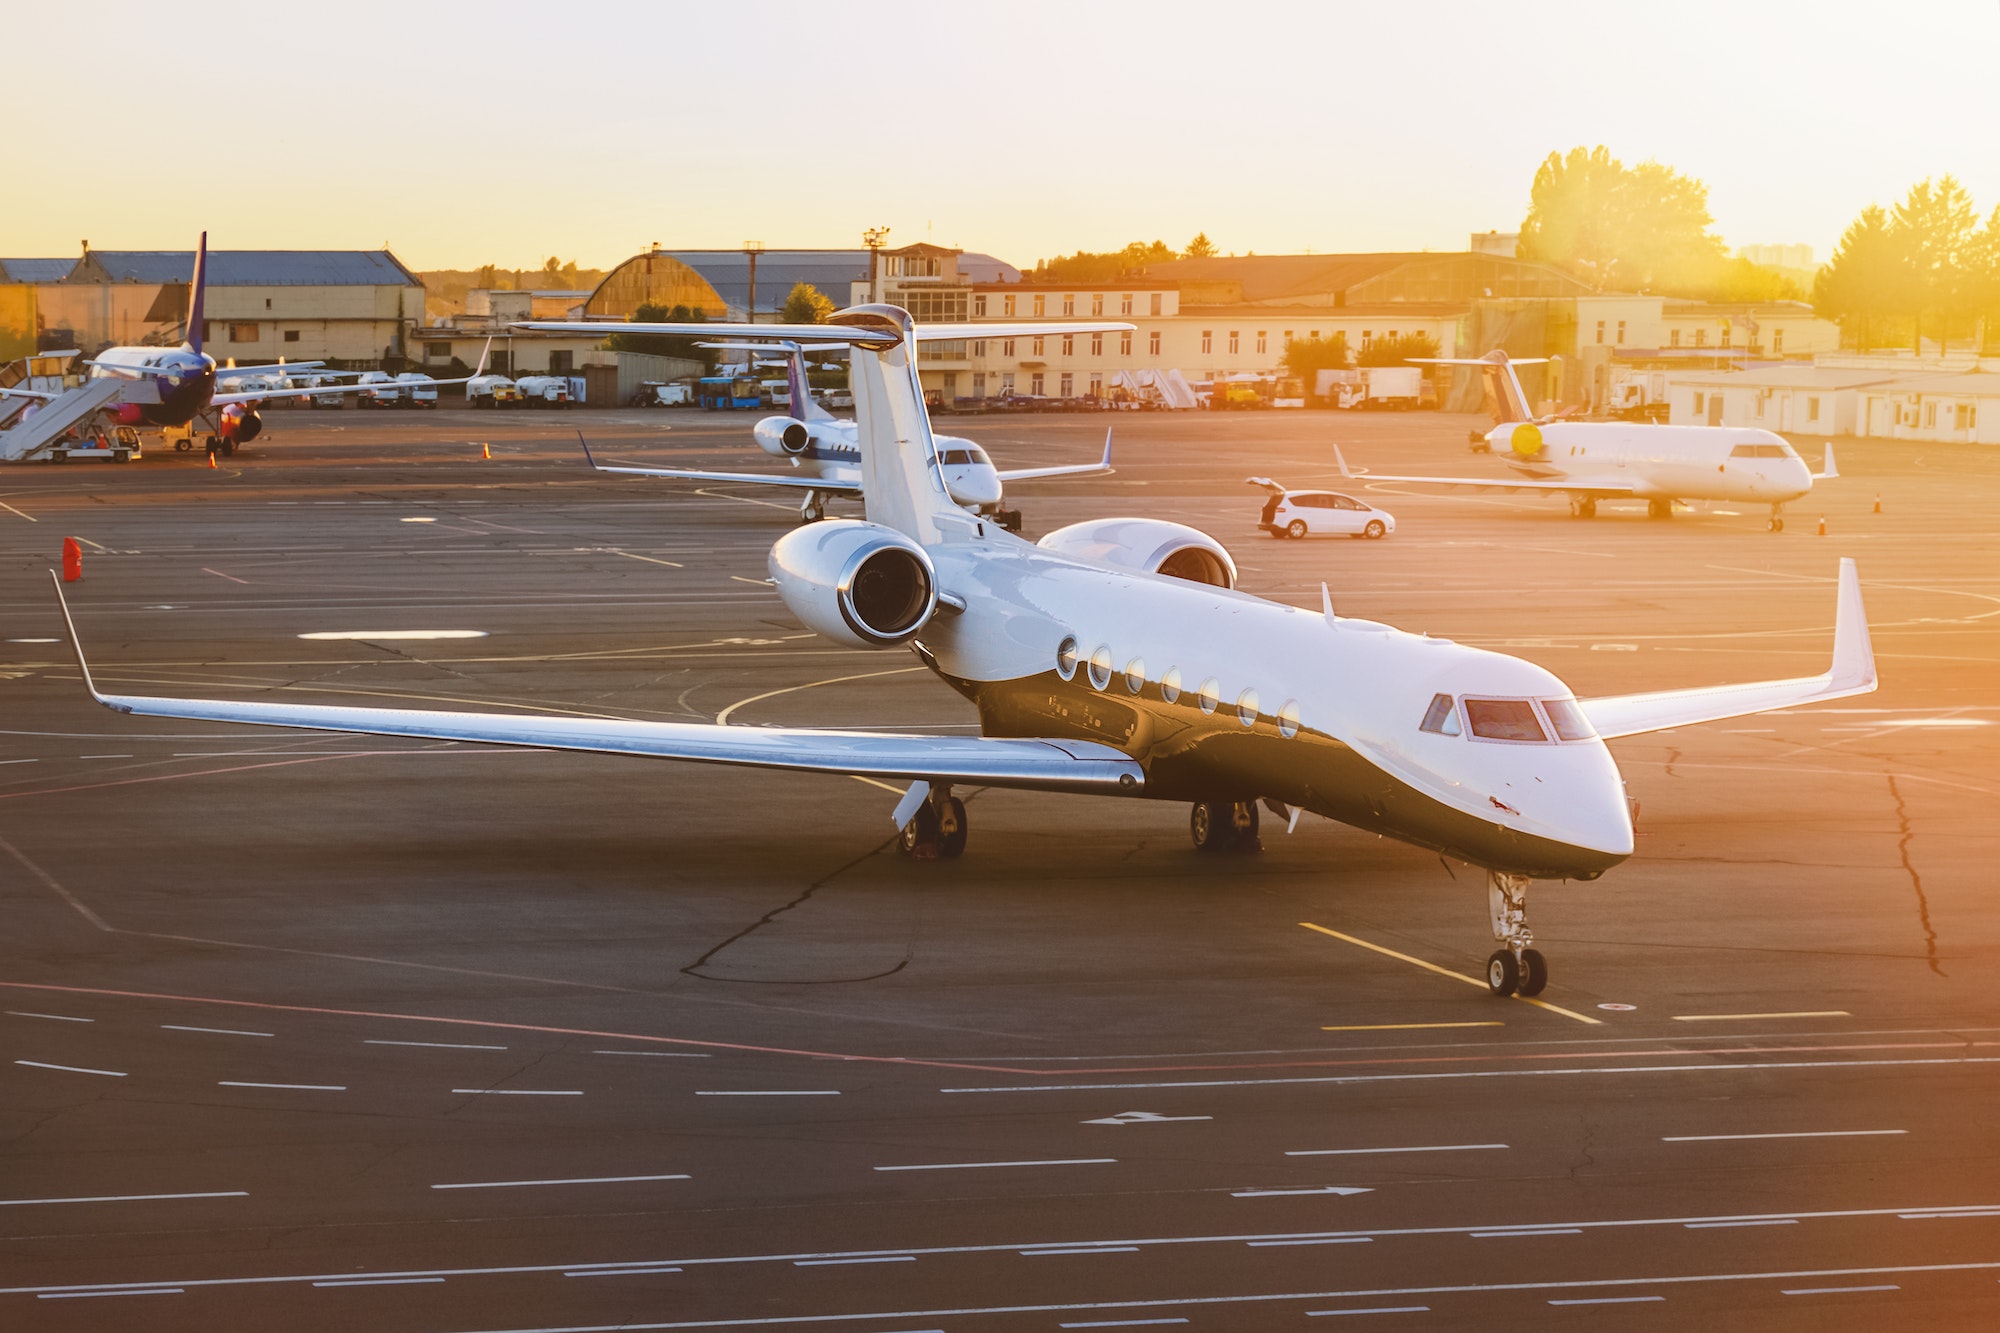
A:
1520 144 1724 296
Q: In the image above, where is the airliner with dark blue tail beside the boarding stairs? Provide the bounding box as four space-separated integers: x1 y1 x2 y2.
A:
8 232 492 454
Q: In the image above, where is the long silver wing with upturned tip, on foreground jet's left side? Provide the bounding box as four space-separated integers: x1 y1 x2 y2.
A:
50 570 1146 795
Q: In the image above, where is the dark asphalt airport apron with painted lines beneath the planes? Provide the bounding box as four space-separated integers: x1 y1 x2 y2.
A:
0 400 2000 1333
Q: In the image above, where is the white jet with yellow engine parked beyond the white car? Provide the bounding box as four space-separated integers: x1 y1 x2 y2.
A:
1334 350 1840 532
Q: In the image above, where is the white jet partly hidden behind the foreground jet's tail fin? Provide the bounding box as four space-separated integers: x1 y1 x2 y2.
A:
572 334 1112 532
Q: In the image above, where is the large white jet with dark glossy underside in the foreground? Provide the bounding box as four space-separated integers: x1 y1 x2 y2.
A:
52 306 1876 995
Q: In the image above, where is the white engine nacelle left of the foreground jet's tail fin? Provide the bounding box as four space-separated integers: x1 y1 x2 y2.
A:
770 518 938 648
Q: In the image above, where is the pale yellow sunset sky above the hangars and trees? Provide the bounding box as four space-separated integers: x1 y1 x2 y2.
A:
15 0 2000 268
